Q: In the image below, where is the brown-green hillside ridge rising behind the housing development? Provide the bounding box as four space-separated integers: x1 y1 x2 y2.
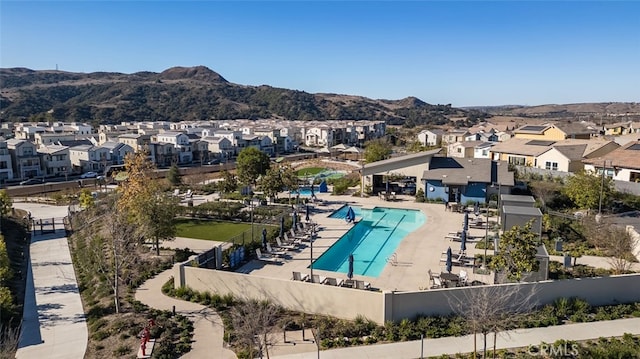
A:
0 66 472 127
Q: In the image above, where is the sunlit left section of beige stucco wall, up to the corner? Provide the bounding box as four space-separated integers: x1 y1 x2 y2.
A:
174 266 384 324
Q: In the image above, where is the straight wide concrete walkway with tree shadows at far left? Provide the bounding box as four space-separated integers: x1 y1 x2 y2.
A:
14 203 88 359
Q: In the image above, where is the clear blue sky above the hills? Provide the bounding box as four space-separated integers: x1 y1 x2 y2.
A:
0 0 640 106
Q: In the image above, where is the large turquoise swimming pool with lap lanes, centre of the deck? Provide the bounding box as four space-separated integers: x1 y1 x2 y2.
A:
313 206 426 277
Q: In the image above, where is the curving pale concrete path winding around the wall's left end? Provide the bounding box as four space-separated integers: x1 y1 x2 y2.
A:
135 238 237 359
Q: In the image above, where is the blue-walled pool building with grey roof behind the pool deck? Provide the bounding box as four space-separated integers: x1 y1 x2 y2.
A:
422 157 514 204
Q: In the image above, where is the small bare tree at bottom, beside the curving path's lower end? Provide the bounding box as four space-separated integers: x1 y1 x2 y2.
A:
231 299 280 358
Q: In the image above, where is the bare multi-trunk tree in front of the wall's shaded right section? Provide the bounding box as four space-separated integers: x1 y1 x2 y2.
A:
447 285 537 358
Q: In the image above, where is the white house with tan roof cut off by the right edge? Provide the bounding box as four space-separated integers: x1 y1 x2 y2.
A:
583 140 640 182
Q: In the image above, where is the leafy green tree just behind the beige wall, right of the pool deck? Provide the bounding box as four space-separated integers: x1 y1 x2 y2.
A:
491 219 540 281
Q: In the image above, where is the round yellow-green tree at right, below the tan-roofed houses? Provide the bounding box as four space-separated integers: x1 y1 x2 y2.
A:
562 171 614 209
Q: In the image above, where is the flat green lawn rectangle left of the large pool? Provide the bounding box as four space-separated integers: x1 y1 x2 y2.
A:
176 219 276 242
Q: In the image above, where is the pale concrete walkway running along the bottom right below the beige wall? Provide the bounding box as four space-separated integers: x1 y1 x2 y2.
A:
270 318 640 359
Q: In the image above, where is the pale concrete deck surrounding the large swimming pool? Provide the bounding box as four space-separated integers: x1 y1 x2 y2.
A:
237 193 495 291
